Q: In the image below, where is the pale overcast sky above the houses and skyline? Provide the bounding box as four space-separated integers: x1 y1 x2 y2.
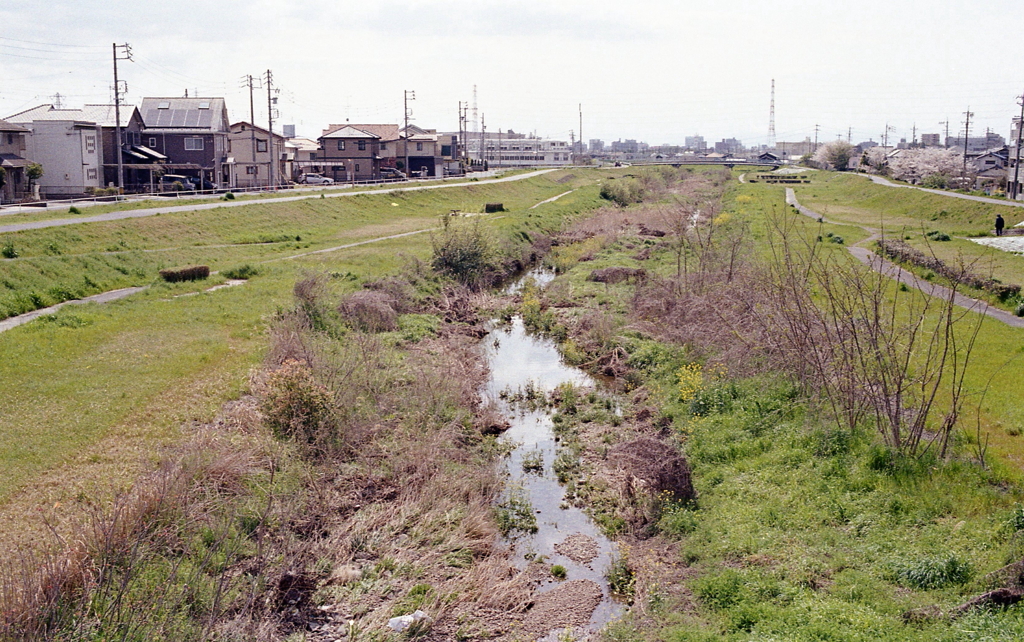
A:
0 0 1024 145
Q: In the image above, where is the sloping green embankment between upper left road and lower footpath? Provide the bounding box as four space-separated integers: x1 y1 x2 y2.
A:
0 172 593 318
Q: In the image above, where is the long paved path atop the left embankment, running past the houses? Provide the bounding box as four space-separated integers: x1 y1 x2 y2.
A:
0 169 555 232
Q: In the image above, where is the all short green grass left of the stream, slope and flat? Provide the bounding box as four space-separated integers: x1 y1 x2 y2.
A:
0 166 598 511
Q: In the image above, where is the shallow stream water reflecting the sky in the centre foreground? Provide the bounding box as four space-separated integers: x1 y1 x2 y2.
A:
483 317 625 630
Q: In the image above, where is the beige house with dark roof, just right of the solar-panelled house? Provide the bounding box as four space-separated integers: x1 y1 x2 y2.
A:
222 121 292 187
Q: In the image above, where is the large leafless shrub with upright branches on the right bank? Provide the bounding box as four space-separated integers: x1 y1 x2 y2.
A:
763 205 984 456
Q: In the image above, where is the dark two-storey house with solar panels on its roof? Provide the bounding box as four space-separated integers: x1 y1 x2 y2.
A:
138 98 230 184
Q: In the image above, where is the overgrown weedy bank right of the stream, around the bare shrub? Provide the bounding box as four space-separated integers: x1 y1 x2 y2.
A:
471 167 1024 641
